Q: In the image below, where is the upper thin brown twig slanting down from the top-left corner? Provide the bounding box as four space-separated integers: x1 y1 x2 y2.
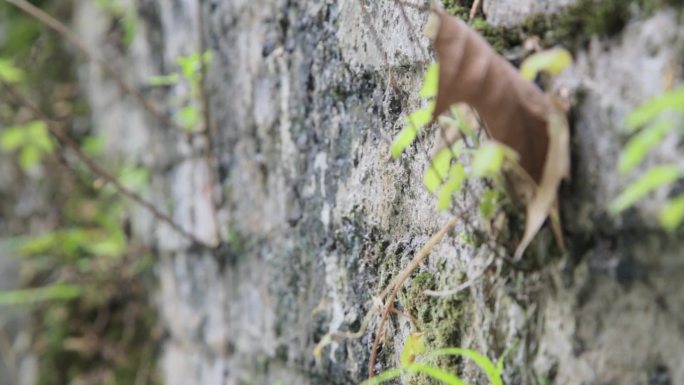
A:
5 0 183 132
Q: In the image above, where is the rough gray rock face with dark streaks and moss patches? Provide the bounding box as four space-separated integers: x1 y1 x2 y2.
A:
75 0 684 385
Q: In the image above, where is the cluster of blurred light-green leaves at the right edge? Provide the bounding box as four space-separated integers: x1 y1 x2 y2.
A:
610 87 684 231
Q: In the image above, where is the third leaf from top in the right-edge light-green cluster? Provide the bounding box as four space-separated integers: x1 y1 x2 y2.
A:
609 165 684 214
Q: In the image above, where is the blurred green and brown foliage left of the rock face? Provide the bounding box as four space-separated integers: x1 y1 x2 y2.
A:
0 0 162 385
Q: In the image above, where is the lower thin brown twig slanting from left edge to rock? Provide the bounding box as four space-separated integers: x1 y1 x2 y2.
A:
0 79 215 249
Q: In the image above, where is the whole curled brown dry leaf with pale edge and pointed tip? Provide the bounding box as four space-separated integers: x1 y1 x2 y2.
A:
426 8 570 258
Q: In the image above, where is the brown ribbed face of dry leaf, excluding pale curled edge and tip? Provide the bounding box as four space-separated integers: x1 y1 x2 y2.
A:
432 9 551 183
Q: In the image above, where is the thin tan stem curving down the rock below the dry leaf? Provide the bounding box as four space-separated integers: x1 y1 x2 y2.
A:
368 211 465 379
